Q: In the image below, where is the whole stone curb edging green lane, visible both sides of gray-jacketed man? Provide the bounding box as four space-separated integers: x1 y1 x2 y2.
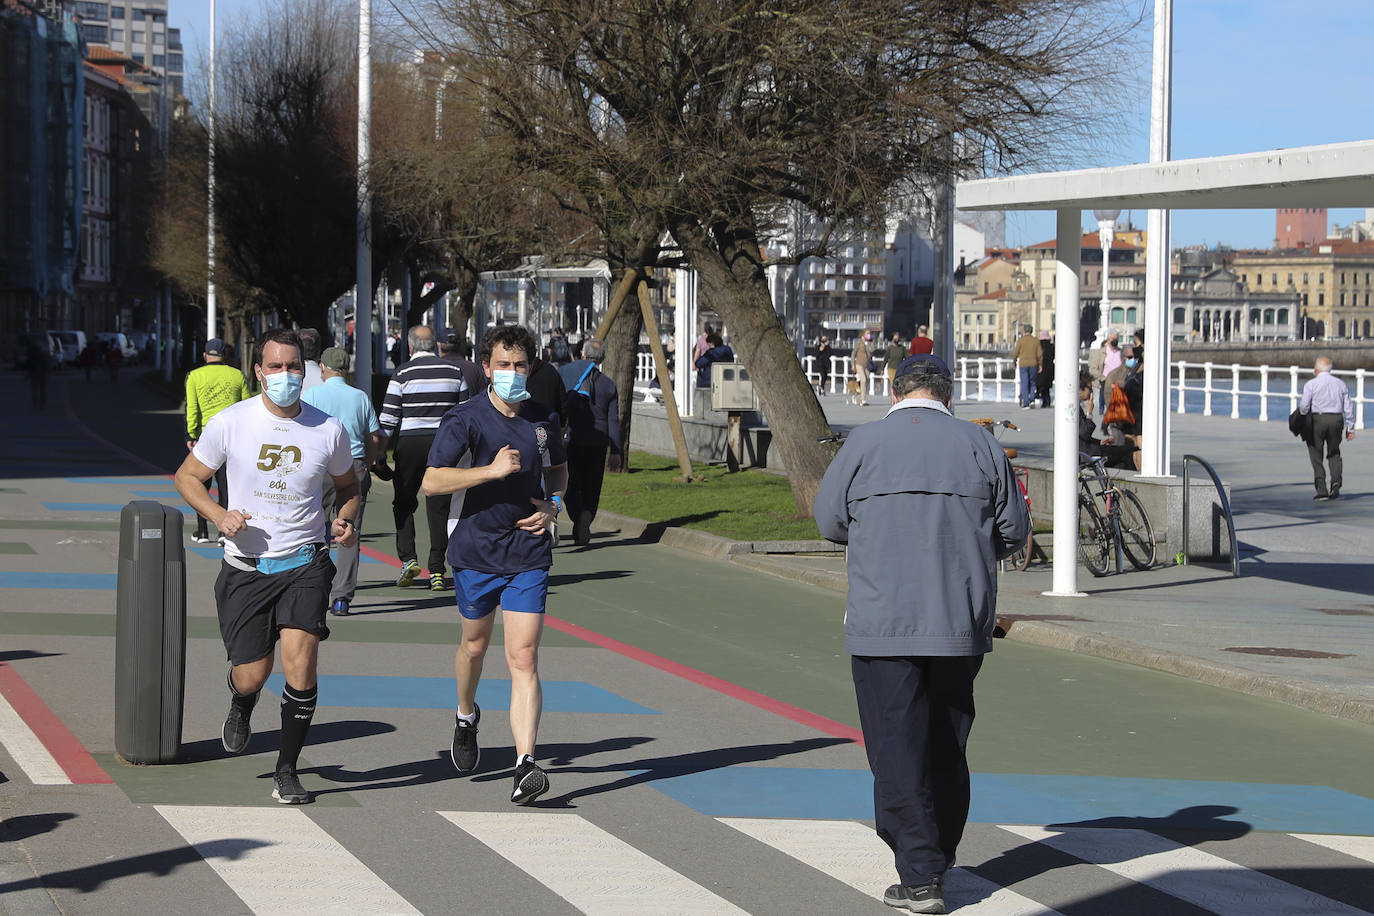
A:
598 511 1374 725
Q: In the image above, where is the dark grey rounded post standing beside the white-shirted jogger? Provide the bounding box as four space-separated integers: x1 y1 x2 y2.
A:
114 500 185 764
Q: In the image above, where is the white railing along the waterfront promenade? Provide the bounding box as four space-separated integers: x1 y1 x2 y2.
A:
635 353 1371 430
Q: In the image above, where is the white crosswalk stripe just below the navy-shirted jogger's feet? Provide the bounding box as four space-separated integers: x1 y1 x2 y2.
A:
438 812 745 916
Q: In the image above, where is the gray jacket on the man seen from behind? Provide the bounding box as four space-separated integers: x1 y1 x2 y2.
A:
815 398 1031 656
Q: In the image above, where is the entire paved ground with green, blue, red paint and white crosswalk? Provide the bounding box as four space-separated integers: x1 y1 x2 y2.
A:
0 372 1374 916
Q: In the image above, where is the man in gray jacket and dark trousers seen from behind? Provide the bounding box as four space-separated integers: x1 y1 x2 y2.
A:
815 354 1031 913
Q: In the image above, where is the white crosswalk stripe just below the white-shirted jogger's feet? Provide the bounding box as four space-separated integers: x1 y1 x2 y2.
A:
155 805 419 916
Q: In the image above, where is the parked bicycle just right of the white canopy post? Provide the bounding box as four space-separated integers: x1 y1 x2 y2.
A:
1079 455 1157 577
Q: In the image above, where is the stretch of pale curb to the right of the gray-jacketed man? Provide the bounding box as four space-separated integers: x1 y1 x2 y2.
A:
1006 621 1374 725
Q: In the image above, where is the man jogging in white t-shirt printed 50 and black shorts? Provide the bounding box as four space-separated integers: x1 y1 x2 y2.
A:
176 328 359 805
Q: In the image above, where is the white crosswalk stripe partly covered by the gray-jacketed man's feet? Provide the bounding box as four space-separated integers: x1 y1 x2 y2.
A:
716 817 1061 916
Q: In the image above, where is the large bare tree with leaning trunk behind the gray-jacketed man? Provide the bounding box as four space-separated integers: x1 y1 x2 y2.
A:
418 0 1135 515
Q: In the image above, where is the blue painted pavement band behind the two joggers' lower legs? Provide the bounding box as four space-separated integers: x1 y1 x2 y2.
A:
267 674 660 715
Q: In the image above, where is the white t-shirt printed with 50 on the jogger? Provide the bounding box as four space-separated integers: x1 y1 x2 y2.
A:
191 396 353 558
